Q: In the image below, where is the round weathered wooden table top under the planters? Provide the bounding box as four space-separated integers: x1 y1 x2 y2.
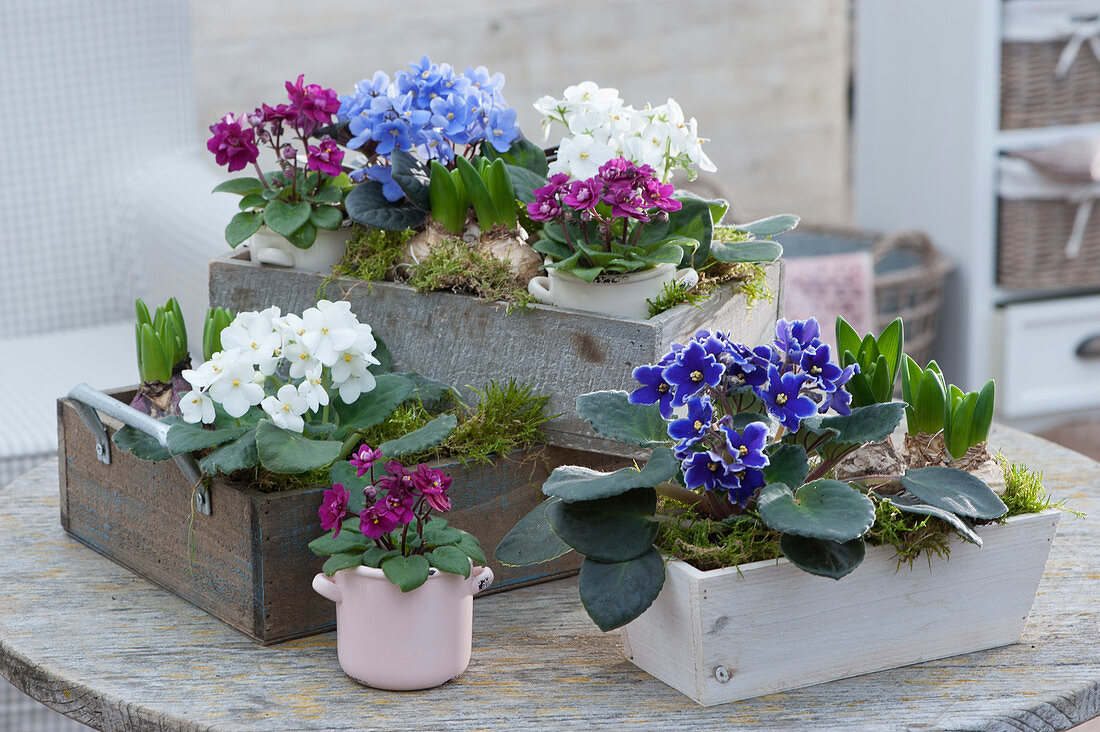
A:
0 428 1100 731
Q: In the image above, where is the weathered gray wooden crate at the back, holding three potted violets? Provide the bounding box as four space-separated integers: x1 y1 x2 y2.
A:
210 250 783 456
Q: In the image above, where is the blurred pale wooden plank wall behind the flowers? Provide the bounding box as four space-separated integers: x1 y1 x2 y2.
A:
191 0 849 223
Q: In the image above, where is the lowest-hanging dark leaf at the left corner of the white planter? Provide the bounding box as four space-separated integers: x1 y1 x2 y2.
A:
580 547 664 632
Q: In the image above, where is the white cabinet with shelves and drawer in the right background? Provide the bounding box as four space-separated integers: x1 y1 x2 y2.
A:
853 0 1100 418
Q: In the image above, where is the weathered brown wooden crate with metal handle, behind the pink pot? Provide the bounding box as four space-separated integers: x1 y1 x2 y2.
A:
58 400 626 643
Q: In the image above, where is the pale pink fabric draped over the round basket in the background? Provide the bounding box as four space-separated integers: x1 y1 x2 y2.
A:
783 251 875 360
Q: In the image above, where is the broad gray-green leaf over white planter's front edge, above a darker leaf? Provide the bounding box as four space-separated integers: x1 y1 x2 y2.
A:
757 479 875 542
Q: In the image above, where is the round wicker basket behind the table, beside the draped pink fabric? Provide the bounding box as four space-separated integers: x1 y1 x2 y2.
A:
871 230 955 364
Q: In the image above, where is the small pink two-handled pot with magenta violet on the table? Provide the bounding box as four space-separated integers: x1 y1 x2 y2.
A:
314 567 493 691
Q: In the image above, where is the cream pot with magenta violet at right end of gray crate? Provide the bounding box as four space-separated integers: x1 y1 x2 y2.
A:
527 263 699 320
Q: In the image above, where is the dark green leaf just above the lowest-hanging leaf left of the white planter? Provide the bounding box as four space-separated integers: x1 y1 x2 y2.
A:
547 488 658 561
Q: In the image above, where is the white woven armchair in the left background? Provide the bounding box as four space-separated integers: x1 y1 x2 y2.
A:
0 0 235 485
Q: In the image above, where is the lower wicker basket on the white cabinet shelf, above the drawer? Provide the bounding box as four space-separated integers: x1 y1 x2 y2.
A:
997 198 1100 289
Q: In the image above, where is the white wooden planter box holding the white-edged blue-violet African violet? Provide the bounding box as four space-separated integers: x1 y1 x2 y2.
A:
622 511 1059 706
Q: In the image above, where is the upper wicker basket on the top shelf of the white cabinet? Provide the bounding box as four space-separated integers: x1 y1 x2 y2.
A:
1001 41 1100 130
